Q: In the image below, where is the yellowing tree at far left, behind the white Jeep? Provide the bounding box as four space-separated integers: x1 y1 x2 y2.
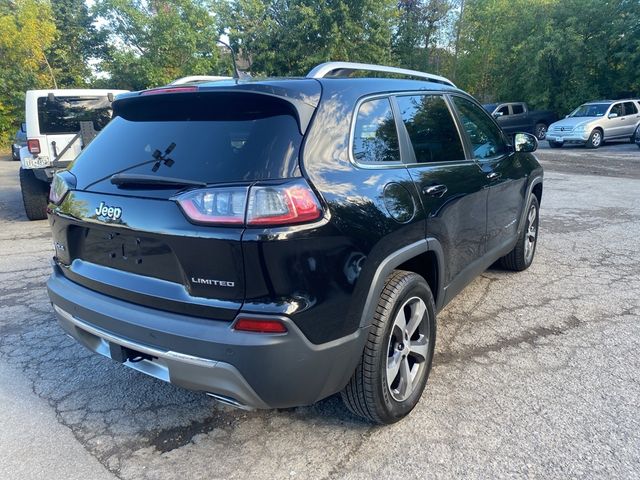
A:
0 0 56 145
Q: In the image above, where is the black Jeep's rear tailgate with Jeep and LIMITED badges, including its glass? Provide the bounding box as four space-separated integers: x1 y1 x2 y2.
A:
50 84 320 321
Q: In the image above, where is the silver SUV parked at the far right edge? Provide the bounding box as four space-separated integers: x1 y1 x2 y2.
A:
547 99 640 148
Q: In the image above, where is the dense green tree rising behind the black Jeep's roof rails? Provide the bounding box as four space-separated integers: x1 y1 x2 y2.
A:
218 0 397 75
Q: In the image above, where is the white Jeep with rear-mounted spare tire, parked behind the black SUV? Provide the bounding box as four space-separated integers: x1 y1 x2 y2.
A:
20 89 126 220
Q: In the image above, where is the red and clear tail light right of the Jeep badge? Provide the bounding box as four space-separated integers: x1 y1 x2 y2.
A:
176 179 322 227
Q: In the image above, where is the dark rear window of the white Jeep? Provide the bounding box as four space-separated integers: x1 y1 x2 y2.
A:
38 96 112 135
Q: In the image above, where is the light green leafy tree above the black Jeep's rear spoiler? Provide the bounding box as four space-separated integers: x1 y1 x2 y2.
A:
95 0 230 90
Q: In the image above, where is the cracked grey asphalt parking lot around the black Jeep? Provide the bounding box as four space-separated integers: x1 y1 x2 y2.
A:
0 142 640 480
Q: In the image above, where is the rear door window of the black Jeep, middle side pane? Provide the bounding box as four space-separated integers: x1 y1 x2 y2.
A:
397 95 465 163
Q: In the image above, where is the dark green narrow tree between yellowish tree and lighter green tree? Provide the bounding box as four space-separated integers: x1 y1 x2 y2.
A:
48 0 104 88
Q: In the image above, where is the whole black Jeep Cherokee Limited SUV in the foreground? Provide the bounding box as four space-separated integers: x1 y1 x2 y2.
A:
48 62 542 423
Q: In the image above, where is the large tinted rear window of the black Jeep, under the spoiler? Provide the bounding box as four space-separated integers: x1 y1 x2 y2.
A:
72 93 302 186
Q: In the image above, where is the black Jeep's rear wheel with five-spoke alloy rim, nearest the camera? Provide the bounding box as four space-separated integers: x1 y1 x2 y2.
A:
341 270 436 424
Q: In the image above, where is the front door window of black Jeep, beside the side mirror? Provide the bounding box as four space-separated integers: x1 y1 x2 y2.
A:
451 96 508 159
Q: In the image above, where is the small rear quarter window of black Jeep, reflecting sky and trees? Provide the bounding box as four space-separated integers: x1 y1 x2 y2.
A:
353 98 400 163
